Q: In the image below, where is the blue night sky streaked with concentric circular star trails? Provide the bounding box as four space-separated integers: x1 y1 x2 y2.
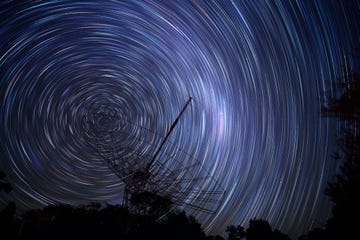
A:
0 1 359 236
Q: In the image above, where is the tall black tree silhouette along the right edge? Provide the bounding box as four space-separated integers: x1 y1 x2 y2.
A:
322 51 360 239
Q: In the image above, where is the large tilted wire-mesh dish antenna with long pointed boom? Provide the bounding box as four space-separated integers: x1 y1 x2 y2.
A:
84 98 224 213
